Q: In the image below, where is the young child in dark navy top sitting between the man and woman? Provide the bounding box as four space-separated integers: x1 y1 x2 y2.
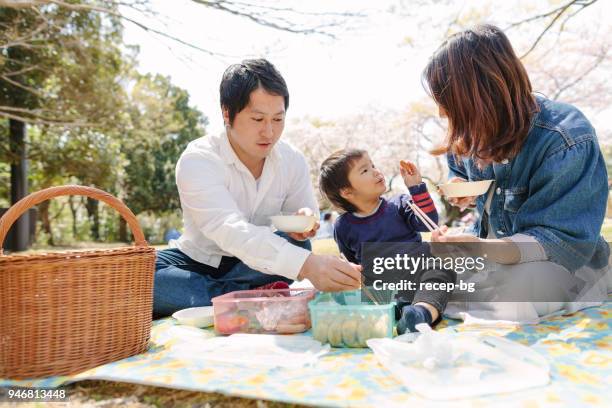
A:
319 149 456 334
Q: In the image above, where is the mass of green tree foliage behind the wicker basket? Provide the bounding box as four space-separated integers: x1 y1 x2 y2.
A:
0 1 206 245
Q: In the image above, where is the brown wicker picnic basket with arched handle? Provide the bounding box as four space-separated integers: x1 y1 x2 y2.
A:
0 186 155 379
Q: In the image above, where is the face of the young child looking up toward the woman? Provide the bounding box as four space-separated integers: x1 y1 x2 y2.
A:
346 153 387 201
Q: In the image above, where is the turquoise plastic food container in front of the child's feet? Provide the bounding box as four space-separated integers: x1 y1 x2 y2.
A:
308 290 395 347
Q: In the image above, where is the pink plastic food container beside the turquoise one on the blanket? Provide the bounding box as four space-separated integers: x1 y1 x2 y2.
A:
212 289 316 334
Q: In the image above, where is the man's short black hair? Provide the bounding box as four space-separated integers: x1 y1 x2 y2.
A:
219 58 289 125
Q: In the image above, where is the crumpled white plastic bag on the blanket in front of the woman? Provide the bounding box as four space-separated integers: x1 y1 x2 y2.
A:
367 331 550 400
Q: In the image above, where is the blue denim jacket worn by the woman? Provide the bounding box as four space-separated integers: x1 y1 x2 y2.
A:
447 96 609 271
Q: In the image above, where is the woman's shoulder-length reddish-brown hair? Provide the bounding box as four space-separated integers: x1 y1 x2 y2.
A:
423 24 537 164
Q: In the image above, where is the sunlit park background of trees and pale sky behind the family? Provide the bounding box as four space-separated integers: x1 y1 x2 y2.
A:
0 0 612 405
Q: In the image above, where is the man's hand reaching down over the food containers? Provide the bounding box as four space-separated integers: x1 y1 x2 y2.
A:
298 254 361 292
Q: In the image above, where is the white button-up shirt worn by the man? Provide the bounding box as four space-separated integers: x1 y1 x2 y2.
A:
170 134 319 279
